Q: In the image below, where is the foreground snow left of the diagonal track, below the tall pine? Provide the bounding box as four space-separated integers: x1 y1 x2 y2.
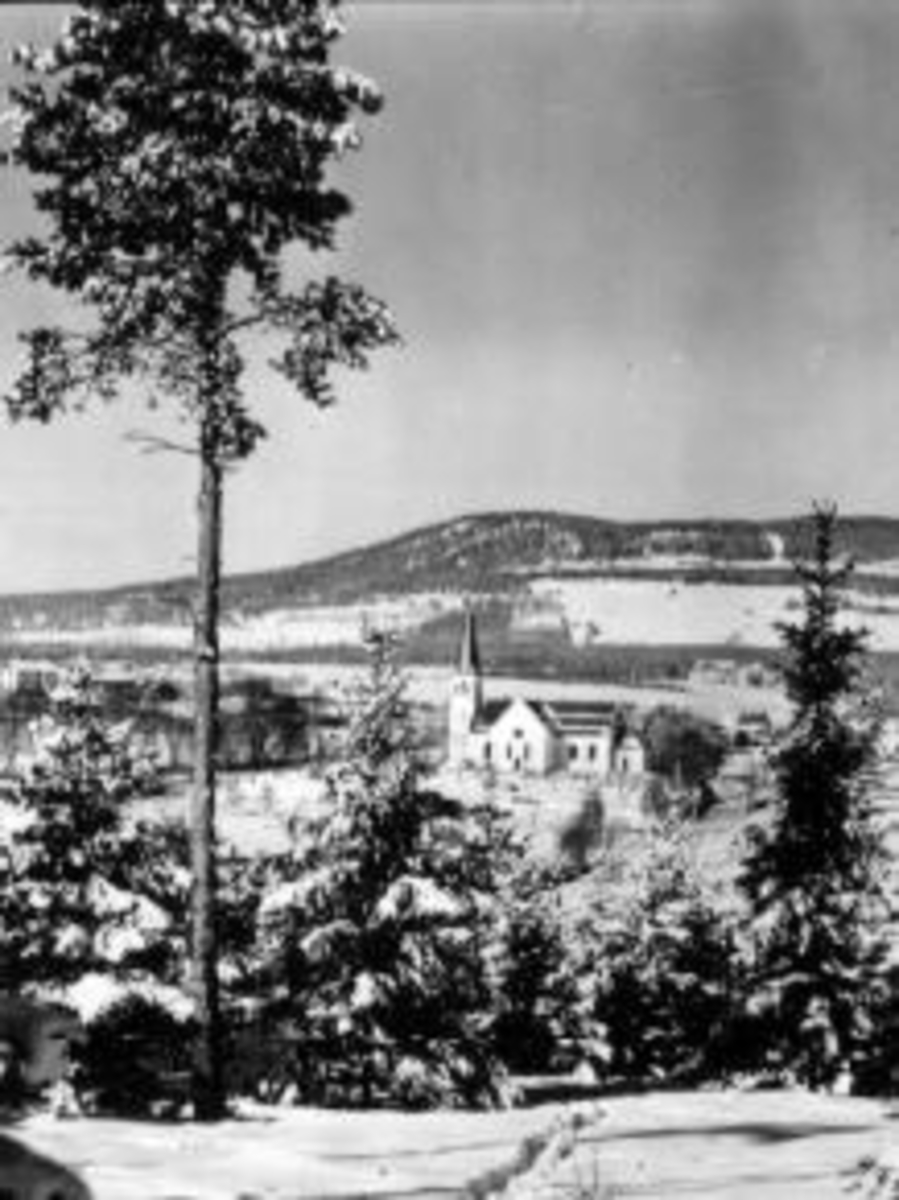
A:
14 1106 588 1200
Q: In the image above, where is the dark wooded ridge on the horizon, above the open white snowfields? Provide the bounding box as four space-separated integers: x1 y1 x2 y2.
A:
0 512 899 630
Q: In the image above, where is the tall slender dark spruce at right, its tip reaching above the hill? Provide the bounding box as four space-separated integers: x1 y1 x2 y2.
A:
742 508 883 1087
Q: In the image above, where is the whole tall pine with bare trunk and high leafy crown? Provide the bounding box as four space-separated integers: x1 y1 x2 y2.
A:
7 0 396 1117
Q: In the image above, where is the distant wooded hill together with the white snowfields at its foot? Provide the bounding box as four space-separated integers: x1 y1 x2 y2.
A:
0 512 899 661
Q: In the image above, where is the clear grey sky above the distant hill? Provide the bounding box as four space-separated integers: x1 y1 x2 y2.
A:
0 0 899 592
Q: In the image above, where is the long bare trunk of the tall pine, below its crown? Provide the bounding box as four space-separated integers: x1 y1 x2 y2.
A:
191 431 224 1121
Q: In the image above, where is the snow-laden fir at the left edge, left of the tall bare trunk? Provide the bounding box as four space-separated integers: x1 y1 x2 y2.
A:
0 668 187 990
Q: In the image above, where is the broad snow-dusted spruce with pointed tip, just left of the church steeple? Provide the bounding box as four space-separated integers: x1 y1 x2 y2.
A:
255 635 504 1106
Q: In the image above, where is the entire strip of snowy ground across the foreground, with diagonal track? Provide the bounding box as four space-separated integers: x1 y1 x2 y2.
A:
8 1091 899 1200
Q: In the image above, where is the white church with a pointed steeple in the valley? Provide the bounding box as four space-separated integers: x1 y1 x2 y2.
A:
448 611 646 780
